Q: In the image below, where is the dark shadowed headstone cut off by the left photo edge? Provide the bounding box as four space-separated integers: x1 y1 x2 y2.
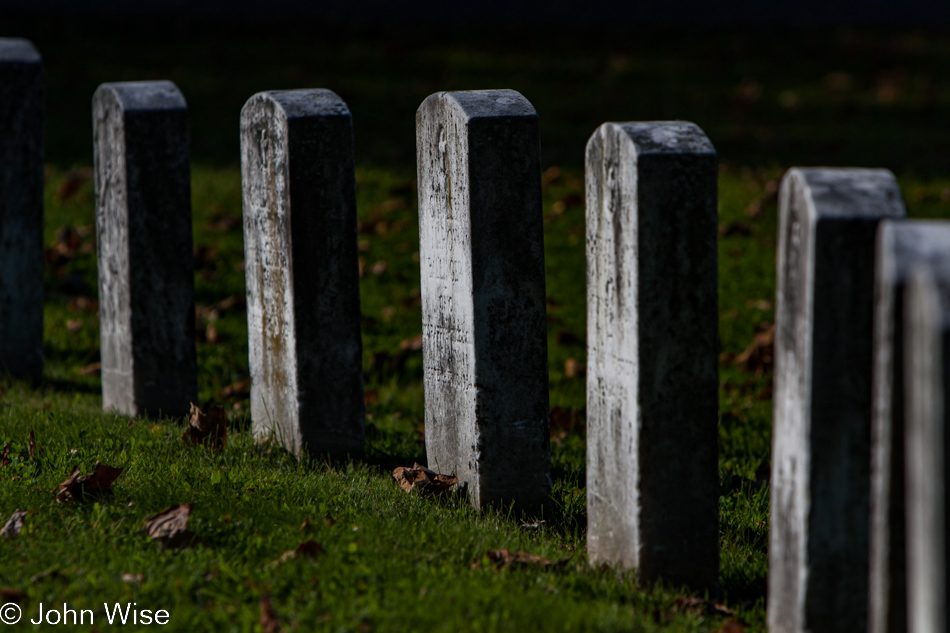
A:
0 38 44 381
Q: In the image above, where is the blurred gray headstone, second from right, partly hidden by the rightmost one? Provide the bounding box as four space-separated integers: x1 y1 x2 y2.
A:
868 221 950 633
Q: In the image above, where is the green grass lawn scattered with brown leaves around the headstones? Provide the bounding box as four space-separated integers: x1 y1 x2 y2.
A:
0 18 950 632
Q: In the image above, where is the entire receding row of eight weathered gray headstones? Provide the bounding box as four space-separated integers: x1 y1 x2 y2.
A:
11 34 950 612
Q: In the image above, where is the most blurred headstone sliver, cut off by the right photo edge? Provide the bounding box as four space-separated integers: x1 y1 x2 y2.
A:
898 259 950 633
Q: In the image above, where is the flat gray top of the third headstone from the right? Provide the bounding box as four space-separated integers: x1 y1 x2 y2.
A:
783 167 906 218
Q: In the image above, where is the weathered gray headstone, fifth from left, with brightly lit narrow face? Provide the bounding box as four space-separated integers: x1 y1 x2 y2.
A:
586 121 719 594
